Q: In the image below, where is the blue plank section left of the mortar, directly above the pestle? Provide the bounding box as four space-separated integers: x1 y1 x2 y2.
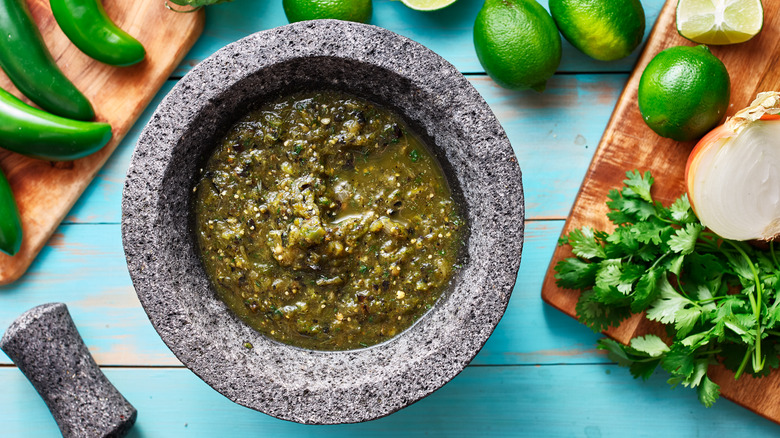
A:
0 224 179 365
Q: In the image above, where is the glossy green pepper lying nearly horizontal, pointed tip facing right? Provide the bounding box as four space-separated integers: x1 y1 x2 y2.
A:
0 89 111 161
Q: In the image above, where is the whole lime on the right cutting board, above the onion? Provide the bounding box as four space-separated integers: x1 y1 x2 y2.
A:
638 46 731 141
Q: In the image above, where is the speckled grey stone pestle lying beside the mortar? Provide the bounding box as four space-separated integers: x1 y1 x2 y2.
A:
0 303 137 438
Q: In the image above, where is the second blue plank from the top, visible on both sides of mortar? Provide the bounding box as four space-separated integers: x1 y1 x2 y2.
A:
65 74 630 223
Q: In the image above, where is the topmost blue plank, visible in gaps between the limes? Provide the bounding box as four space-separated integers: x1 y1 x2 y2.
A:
174 0 664 77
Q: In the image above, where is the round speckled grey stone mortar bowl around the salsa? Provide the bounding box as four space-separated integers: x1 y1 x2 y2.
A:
122 20 524 424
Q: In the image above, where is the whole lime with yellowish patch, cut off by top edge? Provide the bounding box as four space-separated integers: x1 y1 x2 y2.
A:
550 0 645 61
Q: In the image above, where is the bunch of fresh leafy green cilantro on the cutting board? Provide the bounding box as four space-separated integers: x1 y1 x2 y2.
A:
555 171 780 407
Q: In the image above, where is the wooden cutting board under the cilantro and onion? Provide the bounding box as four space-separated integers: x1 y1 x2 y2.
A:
542 0 780 423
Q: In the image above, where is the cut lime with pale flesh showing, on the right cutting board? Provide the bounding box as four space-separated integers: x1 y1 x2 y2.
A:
677 0 764 45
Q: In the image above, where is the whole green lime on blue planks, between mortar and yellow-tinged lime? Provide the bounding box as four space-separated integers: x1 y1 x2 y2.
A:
474 0 561 91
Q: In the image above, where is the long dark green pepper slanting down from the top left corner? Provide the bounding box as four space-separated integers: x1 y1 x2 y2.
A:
0 0 95 120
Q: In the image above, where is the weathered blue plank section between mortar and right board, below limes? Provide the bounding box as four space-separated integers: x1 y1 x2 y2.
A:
471 74 630 219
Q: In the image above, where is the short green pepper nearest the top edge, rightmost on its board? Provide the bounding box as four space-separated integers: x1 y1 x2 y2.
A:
50 0 146 67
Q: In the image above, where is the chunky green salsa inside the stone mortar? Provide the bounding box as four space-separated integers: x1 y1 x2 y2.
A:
194 91 465 350
